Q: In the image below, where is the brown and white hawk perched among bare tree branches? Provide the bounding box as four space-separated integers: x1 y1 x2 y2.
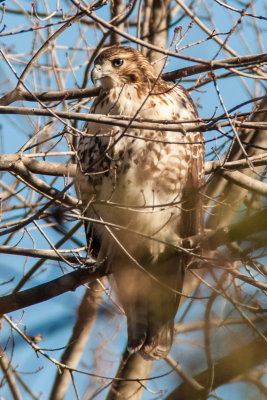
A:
76 46 204 359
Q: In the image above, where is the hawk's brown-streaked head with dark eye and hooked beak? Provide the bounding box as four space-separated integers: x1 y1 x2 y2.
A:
92 46 157 89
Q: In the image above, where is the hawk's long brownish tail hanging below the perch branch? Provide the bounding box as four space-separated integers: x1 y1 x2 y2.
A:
127 254 185 360
